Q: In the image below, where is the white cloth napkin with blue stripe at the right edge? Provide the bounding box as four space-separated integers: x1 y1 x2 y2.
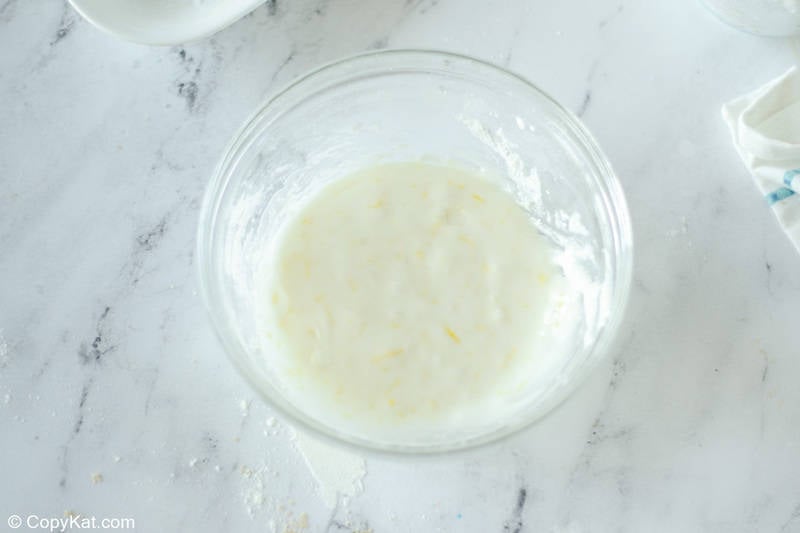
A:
722 67 800 251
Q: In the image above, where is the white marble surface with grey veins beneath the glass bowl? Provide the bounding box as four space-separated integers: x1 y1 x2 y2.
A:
0 0 800 533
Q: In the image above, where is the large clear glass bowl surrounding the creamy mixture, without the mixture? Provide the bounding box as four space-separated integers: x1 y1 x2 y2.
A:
197 50 632 453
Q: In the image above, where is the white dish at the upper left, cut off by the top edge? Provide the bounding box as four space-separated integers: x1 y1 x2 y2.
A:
69 0 264 45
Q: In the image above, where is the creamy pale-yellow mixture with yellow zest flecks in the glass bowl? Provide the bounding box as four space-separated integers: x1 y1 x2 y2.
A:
265 163 563 424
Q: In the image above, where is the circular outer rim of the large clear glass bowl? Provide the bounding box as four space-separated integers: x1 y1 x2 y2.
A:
195 48 633 457
